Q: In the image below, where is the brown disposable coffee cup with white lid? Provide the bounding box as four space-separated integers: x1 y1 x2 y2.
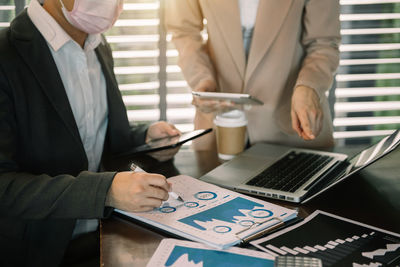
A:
214 110 247 160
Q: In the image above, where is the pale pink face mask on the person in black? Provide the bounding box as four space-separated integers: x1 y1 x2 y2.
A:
60 0 124 34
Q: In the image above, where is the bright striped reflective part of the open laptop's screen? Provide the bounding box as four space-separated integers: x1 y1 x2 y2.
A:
345 130 400 176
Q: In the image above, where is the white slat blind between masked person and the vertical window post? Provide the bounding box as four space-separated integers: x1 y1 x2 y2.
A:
106 0 160 123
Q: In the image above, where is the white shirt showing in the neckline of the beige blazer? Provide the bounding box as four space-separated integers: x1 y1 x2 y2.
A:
238 0 259 58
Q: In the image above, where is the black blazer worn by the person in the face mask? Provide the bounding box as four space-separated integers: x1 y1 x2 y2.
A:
0 10 147 266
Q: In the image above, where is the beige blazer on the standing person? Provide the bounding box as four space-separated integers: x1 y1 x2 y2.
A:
166 0 340 150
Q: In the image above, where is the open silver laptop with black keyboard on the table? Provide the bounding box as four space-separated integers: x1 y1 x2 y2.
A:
200 130 400 203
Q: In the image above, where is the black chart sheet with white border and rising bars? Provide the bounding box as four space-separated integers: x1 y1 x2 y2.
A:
251 210 400 267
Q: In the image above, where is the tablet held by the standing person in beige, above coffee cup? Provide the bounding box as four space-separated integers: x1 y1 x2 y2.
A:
192 91 264 105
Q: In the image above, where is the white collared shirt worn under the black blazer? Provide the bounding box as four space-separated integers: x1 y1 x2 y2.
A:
28 0 108 239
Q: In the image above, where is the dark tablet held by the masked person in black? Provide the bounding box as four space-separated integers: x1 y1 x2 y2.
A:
124 128 212 155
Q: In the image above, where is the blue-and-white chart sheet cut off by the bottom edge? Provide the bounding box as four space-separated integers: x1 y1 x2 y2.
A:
147 238 274 267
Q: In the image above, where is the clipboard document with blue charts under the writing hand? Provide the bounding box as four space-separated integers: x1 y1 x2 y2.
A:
116 175 297 249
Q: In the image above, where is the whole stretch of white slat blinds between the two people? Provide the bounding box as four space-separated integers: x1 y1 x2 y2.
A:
107 0 194 131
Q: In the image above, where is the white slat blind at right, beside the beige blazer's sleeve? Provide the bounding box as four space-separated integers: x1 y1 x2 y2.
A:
334 0 400 144
